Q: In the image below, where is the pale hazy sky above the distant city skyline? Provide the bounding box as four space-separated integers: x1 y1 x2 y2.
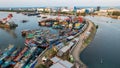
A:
0 0 120 7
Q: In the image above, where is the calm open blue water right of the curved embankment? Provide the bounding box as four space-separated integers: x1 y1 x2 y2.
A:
80 16 120 68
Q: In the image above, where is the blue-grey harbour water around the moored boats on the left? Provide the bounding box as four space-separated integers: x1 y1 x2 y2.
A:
0 12 57 50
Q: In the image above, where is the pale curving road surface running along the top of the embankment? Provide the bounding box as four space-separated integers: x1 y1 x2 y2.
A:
71 19 93 68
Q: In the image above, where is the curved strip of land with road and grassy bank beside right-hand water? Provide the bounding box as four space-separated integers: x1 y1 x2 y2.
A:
71 20 96 68
